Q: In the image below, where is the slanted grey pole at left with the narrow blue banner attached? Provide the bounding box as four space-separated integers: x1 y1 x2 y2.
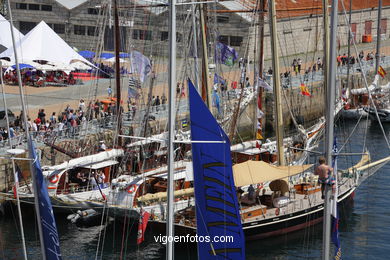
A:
8 1 46 260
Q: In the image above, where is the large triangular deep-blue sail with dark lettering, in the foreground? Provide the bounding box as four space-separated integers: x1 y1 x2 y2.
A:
188 80 245 259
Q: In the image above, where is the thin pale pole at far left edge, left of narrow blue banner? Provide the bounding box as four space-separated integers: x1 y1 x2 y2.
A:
0 60 27 260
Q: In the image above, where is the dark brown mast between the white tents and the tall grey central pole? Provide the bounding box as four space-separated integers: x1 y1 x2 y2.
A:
114 0 122 146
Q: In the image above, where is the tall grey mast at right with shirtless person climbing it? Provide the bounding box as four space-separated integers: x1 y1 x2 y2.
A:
322 0 338 260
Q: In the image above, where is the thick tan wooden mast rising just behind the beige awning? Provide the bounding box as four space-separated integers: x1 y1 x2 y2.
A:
268 0 285 166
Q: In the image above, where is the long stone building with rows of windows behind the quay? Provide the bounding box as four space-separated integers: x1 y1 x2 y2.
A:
3 0 390 59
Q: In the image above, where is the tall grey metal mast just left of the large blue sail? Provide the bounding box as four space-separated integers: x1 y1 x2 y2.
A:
166 0 176 260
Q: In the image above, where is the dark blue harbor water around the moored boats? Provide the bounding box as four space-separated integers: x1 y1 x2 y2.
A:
0 121 390 260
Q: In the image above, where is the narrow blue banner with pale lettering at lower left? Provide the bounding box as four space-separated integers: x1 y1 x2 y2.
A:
29 138 62 260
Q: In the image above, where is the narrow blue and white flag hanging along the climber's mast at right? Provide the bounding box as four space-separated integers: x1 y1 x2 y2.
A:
331 138 341 259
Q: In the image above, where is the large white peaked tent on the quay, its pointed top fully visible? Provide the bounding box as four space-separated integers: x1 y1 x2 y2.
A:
0 21 93 66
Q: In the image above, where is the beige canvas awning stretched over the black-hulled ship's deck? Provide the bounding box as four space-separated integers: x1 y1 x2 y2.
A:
233 161 313 187
